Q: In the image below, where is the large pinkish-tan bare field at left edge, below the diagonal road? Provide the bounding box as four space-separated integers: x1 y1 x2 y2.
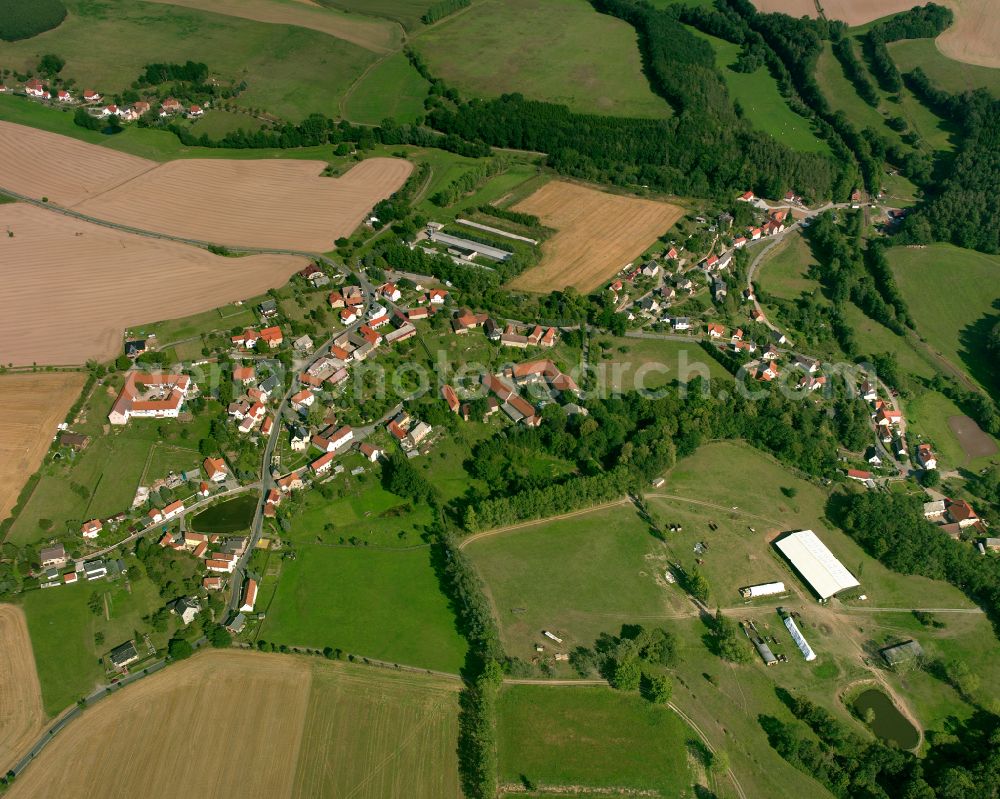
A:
0 203 306 364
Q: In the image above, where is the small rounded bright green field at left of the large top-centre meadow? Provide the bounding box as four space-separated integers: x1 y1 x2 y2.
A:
341 53 430 125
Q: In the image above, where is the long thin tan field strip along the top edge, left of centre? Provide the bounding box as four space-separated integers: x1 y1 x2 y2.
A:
138 0 400 53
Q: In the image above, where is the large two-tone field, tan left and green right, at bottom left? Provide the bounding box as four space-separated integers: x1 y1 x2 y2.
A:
8 650 461 799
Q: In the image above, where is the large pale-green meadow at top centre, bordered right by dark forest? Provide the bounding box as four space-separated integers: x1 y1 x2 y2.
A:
414 0 671 118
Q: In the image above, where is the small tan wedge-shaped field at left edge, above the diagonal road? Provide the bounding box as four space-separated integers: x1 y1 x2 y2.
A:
0 121 157 205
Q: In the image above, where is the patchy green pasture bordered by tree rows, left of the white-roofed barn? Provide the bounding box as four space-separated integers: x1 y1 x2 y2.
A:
466 504 687 661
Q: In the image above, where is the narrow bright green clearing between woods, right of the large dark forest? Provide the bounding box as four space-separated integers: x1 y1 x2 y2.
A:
689 28 830 153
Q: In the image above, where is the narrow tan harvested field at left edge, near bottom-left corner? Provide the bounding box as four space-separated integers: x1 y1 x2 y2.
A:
0 605 45 773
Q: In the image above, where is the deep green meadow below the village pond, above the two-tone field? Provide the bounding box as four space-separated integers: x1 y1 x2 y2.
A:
258 544 466 673
